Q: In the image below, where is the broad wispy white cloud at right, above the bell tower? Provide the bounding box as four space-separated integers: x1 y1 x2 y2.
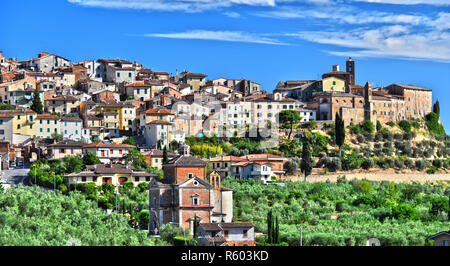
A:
289 25 450 63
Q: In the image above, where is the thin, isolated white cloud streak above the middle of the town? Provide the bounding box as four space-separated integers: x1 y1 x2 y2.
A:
139 30 289 45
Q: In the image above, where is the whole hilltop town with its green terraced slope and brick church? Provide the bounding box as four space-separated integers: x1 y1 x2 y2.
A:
0 52 450 245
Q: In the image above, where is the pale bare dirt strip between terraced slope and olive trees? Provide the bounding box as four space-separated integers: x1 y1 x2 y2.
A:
288 173 450 182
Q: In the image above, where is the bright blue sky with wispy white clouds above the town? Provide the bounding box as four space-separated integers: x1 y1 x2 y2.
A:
0 0 450 132
